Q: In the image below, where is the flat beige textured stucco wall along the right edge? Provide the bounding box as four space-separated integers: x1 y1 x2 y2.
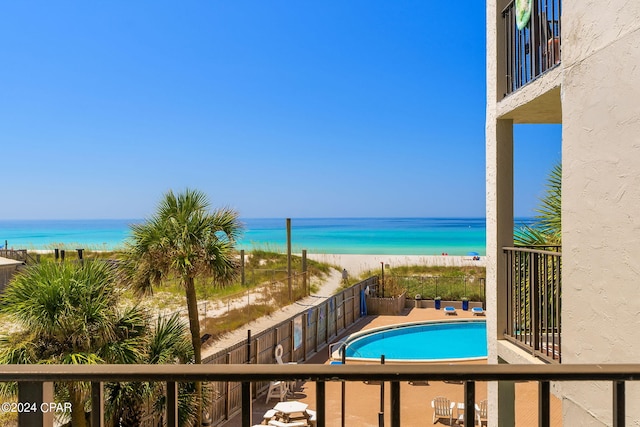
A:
562 0 640 425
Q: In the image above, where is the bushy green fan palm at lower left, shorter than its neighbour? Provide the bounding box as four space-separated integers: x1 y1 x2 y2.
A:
0 262 147 427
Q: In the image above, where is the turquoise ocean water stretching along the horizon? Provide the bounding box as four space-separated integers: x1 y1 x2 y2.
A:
0 218 486 255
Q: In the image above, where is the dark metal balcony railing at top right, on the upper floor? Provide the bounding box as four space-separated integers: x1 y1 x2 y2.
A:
502 0 562 95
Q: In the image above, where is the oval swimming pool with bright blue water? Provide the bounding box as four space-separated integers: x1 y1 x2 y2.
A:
334 320 487 362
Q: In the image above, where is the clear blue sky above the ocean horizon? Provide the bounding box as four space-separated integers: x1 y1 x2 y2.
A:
0 0 560 219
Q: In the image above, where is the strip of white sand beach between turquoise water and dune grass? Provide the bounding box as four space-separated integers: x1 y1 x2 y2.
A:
307 254 486 275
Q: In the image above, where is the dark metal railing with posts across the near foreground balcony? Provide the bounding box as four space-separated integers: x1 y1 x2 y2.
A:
0 364 640 427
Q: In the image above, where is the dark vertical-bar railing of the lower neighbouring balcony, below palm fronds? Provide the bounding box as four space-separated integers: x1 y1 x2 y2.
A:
504 247 562 363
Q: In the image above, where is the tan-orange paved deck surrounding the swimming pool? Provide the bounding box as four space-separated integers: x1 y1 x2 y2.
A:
224 308 562 427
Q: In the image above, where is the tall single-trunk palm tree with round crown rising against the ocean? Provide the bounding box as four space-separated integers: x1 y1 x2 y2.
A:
124 189 242 424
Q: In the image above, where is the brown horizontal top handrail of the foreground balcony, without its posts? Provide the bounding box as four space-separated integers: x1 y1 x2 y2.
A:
0 363 640 382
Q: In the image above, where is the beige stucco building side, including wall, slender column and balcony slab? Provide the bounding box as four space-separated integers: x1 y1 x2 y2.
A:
486 0 640 426
